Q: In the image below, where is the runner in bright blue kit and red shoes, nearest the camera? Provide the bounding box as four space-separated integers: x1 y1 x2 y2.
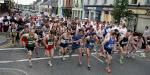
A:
102 31 116 73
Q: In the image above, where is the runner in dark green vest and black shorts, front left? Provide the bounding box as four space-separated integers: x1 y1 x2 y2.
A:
20 30 37 67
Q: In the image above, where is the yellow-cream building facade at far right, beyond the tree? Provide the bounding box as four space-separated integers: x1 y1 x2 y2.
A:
129 0 150 32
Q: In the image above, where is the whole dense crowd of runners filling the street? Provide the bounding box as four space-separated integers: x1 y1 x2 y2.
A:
0 14 150 73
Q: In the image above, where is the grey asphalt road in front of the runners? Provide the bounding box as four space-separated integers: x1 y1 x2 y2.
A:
0 49 150 75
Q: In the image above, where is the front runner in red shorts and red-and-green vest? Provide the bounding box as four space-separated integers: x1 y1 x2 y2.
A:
43 31 55 67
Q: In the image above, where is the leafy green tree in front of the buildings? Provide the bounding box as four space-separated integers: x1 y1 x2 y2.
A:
112 0 129 23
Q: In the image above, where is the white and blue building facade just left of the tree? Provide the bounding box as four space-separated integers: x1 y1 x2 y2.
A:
84 0 114 22
